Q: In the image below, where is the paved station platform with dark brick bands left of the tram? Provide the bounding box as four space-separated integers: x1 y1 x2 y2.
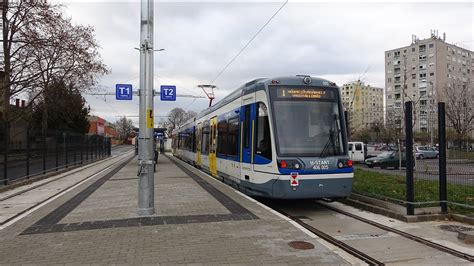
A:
0 153 360 265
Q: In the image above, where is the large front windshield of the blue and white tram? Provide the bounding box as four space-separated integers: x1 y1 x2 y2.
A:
272 89 344 157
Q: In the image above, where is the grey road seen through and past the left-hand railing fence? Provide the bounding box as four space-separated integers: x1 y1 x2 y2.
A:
0 145 133 185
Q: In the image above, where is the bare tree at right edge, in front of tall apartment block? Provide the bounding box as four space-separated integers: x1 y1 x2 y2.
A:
444 82 474 148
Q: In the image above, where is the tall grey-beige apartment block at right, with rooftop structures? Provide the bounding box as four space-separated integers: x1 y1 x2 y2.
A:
385 31 474 131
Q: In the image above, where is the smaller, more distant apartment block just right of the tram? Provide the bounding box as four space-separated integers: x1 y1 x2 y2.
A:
341 80 383 133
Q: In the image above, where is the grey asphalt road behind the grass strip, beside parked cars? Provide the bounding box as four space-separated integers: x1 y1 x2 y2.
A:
356 159 474 186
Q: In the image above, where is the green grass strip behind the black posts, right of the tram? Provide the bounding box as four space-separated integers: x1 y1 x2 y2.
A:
352 169 474 214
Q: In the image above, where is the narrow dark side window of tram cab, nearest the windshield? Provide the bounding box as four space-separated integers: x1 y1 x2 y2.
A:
256 102 272 160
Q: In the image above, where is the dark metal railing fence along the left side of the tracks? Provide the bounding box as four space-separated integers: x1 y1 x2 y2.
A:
0 123 111 185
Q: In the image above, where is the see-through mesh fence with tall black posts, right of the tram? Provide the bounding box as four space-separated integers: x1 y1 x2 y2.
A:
354 102 474 216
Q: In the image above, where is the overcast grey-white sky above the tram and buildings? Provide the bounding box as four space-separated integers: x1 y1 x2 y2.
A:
62 1 474 125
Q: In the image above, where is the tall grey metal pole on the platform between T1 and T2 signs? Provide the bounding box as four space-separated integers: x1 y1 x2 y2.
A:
137 0 155 216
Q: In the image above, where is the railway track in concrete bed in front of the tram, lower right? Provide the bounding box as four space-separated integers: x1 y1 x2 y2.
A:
261 200 474 265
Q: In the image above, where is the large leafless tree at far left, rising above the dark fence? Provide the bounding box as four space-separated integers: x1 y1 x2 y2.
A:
3 0 108 131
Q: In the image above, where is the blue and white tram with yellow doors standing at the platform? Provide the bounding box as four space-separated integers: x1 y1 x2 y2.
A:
173 76 353 199
